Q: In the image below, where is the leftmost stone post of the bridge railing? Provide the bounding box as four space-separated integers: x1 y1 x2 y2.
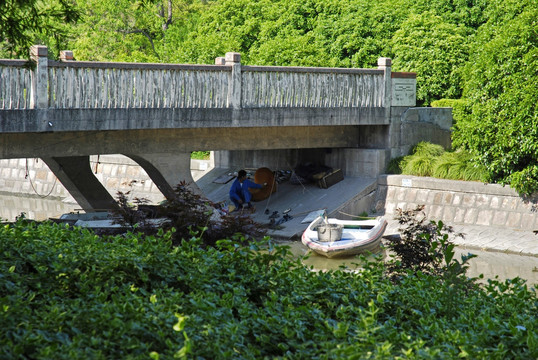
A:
30 45 49 109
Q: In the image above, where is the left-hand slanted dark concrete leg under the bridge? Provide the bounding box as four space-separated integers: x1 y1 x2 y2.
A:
43 156 118 212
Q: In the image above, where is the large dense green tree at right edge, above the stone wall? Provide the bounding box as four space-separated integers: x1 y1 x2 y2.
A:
453 1 538 194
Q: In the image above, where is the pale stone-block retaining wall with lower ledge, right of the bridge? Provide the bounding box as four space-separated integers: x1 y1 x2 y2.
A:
376 175 538 256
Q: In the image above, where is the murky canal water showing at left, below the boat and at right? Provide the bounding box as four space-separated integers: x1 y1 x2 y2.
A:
0 194 538 285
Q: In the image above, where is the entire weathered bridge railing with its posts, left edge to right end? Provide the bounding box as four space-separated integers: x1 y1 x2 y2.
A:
0 46 391 109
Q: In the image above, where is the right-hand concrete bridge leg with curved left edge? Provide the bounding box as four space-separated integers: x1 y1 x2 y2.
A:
125 152 202 198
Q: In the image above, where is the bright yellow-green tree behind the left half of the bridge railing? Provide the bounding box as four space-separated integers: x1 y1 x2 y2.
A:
71 0 207 62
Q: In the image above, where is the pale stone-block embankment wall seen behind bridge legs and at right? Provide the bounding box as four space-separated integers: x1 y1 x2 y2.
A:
0 155 538 231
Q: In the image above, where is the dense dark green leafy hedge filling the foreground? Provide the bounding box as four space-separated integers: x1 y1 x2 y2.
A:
0 221 538 359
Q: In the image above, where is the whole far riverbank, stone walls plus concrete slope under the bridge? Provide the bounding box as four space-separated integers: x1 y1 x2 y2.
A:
0 156 538 257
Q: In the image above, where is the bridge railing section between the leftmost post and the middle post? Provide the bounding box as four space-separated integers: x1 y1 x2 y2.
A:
48 61 230 109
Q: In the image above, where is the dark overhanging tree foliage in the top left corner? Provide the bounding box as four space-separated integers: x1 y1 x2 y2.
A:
0 0 79 58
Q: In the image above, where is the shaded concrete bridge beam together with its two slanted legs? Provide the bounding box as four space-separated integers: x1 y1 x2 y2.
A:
0 125 388 211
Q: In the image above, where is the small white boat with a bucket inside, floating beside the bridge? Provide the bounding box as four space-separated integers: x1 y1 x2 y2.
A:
301 216 387 258
